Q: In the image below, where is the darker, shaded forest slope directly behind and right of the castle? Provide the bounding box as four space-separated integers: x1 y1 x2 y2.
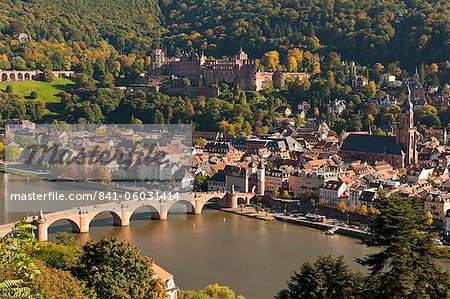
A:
162 0 450 66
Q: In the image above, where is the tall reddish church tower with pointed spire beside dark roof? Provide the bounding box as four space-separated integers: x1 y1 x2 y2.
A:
397 84 418 166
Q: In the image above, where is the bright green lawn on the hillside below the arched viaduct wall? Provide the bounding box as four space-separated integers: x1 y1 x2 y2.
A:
0 78 73 103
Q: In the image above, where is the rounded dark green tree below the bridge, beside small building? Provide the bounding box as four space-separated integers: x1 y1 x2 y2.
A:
76 237 164 299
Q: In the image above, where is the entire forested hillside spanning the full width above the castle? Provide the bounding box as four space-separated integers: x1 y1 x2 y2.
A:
0 0 450 77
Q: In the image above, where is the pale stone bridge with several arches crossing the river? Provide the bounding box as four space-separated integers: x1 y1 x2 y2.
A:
0 192 256 241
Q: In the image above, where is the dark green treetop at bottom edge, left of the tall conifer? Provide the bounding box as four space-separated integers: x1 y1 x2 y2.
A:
276 256 364 299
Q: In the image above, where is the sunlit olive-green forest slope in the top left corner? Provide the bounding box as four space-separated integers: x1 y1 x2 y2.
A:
0 0 161 53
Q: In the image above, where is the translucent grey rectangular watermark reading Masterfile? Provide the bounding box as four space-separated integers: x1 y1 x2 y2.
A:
2 125 194 213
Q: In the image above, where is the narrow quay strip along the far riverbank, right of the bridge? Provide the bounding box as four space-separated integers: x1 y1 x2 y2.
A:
214 206 368 239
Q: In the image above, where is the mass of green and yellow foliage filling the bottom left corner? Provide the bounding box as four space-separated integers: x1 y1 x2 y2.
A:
0 227 164 299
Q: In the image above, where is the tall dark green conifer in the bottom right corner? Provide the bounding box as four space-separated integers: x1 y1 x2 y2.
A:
359 193 450 298
